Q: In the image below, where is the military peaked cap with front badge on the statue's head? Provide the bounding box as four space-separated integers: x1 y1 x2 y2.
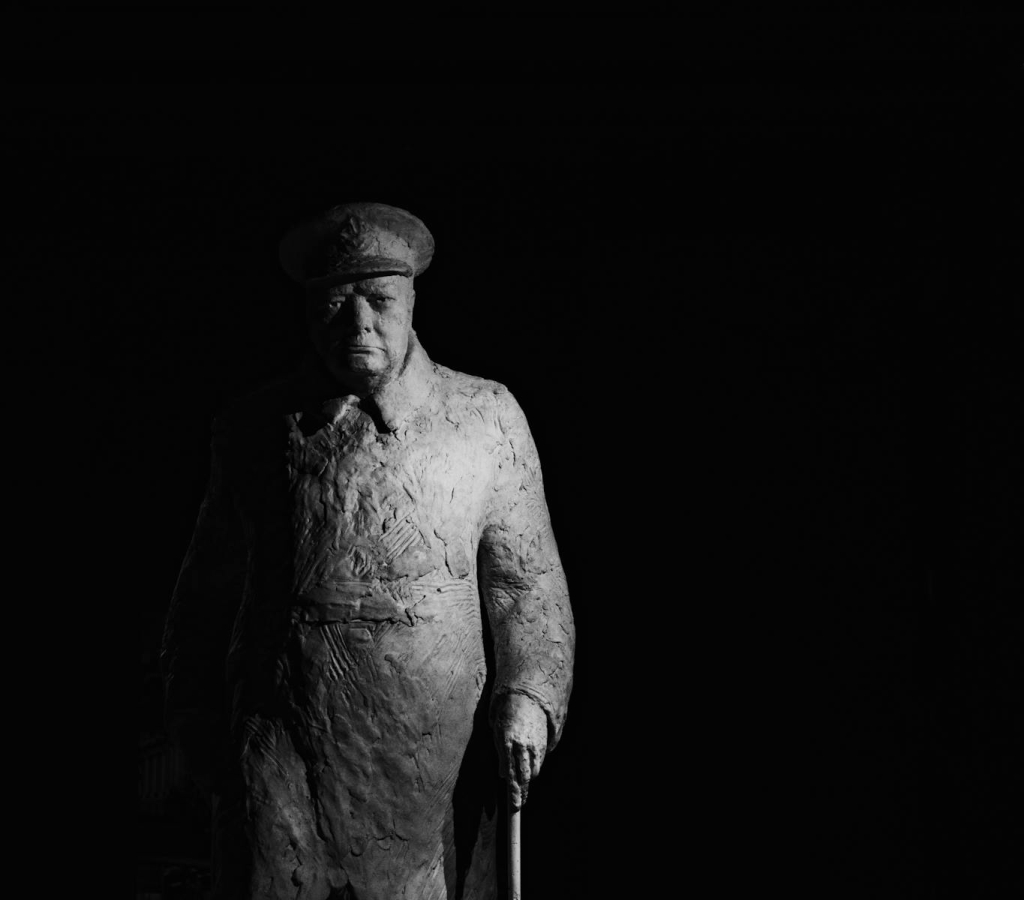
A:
280 203 434 288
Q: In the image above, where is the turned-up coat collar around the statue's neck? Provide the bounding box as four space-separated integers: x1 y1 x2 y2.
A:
303 332 434 432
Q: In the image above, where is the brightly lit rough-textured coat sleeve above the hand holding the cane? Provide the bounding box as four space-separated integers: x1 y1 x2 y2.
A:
478 390 575 748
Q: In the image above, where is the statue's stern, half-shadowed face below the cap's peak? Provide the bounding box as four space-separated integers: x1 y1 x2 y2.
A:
306 275 416 390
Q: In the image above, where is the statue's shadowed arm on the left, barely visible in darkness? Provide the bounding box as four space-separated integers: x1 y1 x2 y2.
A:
160 424 247 787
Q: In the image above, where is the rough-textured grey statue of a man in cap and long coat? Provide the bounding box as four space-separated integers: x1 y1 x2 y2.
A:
162 203 574 900
